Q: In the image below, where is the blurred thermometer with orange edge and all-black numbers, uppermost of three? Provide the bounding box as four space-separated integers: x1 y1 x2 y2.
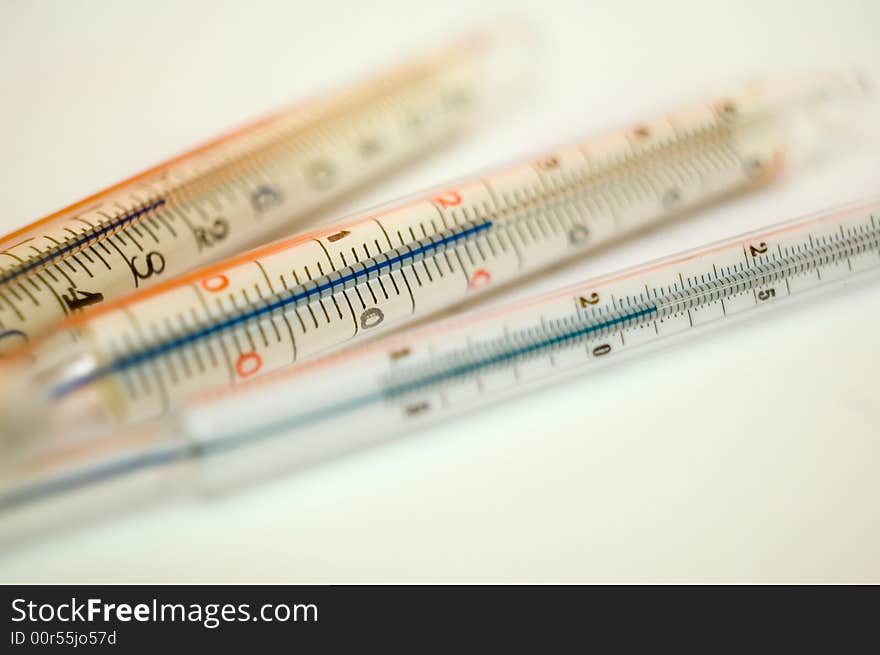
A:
0 24 512 353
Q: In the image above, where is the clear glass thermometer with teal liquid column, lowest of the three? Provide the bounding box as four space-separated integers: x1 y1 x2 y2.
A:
0 200 880 509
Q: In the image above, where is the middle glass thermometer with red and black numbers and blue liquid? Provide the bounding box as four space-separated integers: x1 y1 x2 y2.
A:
4 76 868 440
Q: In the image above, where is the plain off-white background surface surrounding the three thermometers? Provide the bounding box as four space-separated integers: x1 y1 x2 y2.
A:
0 0 880 582
